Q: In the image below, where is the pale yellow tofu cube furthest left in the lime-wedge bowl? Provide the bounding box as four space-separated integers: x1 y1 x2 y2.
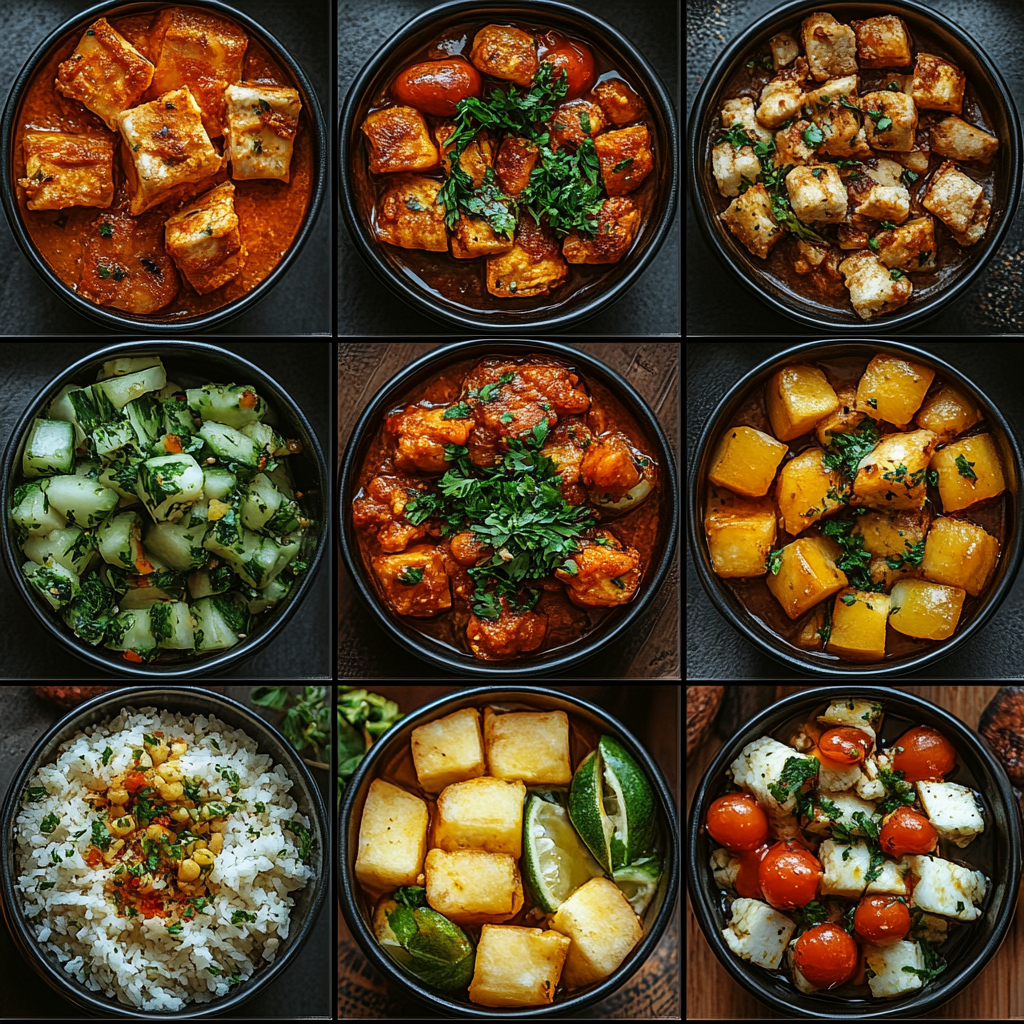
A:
355 778 429 893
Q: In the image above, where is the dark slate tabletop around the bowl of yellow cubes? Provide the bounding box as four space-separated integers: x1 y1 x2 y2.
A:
686 337 1024 680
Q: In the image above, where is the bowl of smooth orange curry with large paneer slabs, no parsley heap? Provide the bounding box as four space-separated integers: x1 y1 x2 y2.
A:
0 0 327 332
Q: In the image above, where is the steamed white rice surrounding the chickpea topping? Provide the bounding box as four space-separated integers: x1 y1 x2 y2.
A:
15 708 312 1011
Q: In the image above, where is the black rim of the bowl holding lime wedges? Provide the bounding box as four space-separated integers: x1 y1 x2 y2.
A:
337 686 680 1017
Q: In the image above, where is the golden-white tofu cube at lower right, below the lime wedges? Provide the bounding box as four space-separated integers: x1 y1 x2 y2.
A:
551 879 643 988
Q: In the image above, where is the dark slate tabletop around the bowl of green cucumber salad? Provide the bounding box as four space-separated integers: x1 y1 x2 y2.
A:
0 338 334 680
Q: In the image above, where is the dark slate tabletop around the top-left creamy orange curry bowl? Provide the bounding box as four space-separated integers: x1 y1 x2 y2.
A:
0 0 334 338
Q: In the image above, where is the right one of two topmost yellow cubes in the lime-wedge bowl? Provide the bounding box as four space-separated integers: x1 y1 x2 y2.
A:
483 708 572 785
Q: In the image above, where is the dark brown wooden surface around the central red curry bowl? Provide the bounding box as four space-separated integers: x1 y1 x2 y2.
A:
337 337 682 679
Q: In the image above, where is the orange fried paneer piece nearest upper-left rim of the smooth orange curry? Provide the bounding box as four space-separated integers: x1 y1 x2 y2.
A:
55 17 154 131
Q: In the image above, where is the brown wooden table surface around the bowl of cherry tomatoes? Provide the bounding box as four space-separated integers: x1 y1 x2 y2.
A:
686 686 1024 1021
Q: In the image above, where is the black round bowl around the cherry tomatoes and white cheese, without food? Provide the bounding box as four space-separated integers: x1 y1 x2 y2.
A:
686 685 1021 1020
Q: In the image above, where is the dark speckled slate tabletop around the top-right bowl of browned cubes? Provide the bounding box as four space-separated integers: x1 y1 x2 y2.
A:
686 0 1024 335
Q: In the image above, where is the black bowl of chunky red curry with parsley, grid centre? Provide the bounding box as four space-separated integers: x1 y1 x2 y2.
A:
339 341 678 677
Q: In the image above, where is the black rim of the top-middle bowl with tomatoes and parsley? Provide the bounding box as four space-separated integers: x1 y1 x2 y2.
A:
337 0 679 335
